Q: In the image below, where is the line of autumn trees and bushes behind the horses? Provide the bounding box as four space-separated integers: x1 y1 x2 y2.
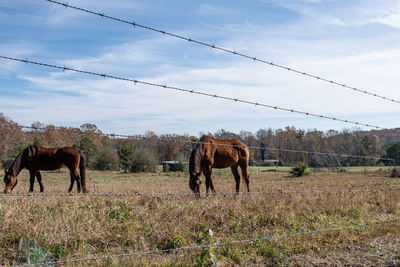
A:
0 113 400 172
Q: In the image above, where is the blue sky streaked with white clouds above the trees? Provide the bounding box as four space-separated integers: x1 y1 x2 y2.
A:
0 0 400 135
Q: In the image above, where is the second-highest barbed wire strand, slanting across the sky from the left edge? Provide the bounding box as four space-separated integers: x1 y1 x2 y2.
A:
0 55 384 129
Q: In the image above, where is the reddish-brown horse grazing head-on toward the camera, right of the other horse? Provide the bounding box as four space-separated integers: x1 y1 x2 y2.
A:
189 136 250 196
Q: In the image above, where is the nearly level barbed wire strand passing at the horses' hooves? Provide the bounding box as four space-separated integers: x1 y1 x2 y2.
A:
0 188 400 197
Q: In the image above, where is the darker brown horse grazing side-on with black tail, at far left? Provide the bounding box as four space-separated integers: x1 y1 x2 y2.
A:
4 145 88 194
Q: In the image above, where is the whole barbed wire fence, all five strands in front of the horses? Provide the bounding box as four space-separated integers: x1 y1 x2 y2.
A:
0 3 400 266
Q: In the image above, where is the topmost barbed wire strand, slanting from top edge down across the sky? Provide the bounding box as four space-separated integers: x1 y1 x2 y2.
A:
46 0 400 103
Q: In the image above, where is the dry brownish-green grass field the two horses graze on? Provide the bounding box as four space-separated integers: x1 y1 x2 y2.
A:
0 167 400 266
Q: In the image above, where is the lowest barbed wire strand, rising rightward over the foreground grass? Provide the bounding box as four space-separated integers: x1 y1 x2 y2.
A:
13 219 399 267
